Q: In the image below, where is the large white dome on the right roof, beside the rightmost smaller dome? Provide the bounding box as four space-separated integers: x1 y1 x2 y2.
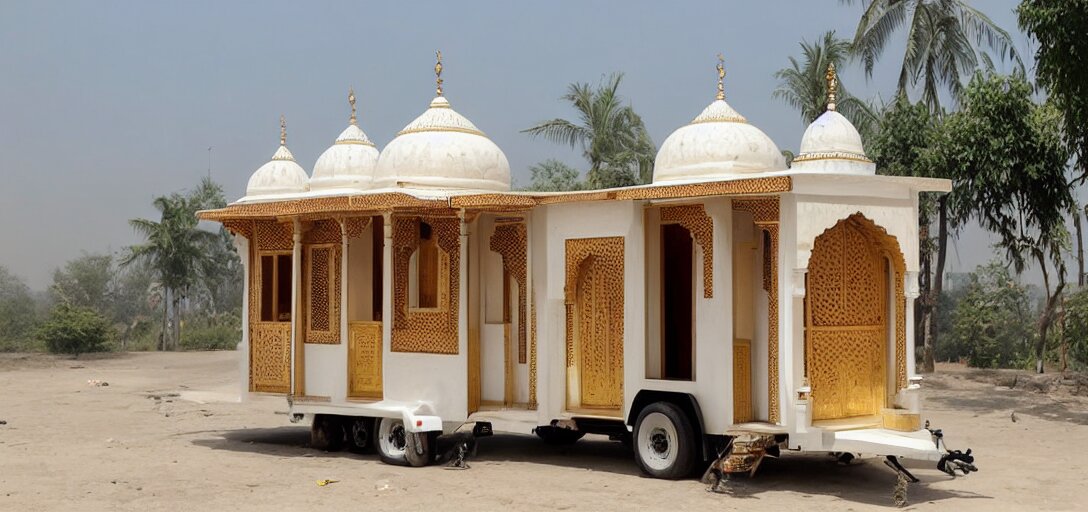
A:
654 100 786 183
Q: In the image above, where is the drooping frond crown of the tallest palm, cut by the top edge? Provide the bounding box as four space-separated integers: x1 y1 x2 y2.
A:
840 0 1024 112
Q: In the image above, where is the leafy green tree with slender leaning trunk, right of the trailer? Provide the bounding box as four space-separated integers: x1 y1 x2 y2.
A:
930 73 1074 373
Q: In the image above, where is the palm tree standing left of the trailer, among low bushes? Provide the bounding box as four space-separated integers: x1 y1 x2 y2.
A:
121 185 218 350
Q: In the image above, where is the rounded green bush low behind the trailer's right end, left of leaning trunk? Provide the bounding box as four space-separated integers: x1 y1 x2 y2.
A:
950 261 1033 367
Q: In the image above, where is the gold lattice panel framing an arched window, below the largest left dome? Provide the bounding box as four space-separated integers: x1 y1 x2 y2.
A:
392 216 461 354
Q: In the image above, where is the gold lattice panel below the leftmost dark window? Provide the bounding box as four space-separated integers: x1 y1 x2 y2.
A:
249 321 290 392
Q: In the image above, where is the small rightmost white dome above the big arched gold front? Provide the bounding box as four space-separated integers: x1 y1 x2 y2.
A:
792 110 876 174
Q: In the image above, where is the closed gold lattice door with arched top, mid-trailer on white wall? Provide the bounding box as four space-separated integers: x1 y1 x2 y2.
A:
566 237 625 408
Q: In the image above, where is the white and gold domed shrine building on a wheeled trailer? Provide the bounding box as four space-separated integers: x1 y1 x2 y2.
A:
199 53 974 486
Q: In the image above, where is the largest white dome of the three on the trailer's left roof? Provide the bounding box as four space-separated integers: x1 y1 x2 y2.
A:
374 96 510 191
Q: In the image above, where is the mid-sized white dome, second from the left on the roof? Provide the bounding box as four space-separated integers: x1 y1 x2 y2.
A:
310 124 378 190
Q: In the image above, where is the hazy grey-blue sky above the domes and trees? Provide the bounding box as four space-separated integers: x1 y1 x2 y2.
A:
0 0 1031 289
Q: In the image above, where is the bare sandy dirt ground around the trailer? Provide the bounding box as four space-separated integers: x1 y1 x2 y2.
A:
0 352 1088 511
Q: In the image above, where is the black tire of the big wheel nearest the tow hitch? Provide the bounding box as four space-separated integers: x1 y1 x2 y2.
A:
632 402 696 479
